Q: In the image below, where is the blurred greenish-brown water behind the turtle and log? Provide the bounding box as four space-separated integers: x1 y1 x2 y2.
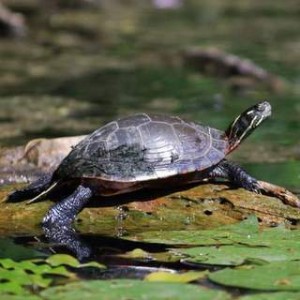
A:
0 0 300 189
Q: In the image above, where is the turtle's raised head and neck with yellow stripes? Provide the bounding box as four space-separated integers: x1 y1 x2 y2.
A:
225 101 271 152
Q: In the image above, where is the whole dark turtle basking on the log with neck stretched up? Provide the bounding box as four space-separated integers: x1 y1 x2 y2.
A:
8 101 271 258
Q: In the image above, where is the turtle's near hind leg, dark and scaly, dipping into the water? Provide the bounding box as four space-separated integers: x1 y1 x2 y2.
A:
43 185 93 260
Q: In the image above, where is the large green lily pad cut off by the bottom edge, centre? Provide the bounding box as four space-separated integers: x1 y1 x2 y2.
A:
41 280 231 300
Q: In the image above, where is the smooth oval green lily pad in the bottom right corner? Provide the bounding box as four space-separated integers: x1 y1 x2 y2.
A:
208 261 300 291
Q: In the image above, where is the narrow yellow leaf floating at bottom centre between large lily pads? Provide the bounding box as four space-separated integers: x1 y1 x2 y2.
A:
145 271 208 283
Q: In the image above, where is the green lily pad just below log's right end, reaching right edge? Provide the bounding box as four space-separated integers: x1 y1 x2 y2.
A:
177 223 300 265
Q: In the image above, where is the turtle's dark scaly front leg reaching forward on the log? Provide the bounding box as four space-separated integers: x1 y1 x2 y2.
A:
209 159 260 193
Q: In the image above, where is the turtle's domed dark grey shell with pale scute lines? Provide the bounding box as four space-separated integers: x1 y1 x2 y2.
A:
55 114 228 182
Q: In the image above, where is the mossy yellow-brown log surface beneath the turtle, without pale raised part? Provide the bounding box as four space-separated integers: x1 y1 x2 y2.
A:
0 180 300 236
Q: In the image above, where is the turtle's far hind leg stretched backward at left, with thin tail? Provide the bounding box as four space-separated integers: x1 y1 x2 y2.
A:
7 174 57 203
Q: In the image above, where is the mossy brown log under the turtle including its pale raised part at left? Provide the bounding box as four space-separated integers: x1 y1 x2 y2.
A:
0 136 300 236
